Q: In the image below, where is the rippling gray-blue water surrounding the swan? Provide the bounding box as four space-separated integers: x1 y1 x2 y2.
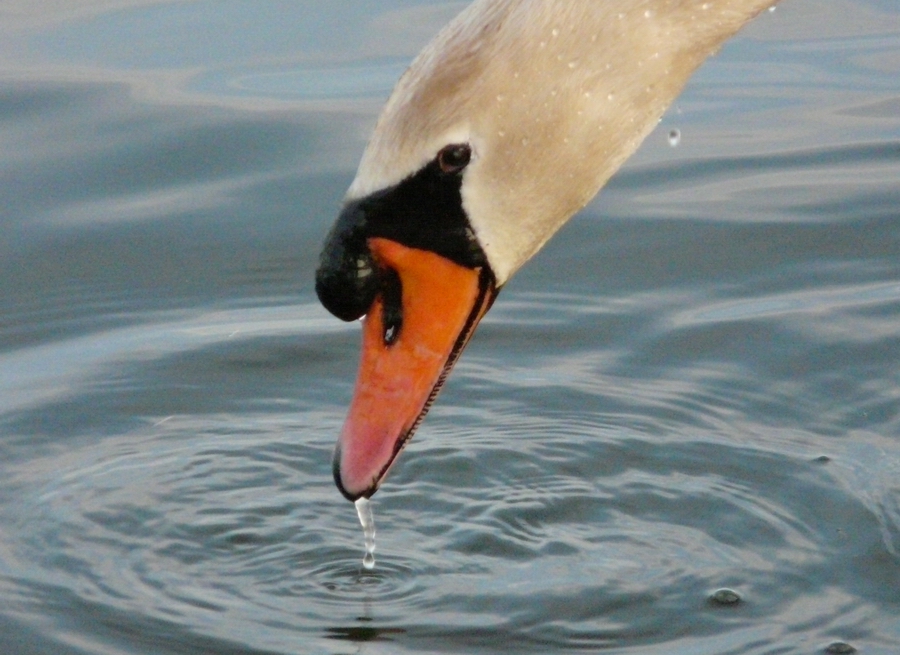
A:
0 0 900 655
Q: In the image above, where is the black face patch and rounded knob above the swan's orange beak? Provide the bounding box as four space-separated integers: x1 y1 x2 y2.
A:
316 144 487 321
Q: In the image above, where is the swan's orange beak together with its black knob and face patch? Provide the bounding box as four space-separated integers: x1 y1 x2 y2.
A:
316 128 499 500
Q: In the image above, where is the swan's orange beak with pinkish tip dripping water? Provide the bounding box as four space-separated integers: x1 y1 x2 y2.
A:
334 237 497 500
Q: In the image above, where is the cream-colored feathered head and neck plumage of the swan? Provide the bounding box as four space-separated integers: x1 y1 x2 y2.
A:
348 0 771 284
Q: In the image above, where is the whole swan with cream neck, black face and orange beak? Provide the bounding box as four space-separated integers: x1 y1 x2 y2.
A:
316 0 772 501
